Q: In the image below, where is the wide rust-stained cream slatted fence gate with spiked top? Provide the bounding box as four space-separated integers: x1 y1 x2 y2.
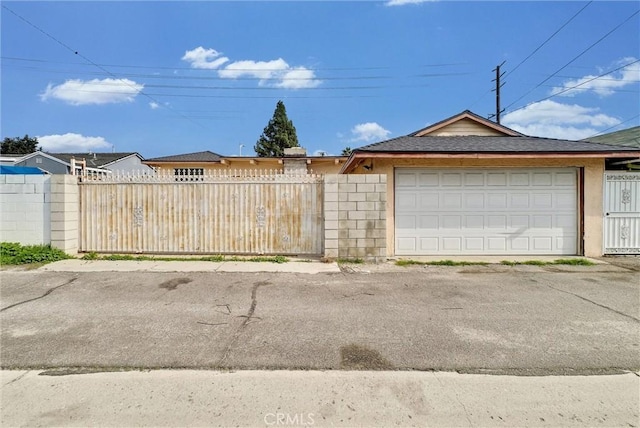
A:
80 171 324 255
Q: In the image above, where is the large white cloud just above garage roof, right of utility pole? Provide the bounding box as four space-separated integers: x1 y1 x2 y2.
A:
502 100 620 140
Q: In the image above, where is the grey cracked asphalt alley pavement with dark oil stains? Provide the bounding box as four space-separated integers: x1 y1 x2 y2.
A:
0 266 640 375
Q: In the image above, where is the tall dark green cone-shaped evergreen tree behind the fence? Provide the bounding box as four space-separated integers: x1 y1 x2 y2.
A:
253 101 298 157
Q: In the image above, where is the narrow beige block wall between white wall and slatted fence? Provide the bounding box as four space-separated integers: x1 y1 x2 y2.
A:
51 174 80 254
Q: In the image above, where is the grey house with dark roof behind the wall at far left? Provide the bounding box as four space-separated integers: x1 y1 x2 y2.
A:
15 151 153 174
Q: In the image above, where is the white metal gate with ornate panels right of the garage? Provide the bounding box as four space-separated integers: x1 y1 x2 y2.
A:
603 171 640 254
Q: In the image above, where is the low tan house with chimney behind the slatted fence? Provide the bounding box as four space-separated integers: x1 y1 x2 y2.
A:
143 147 347 181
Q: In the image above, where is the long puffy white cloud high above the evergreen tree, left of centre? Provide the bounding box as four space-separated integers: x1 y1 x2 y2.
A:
182 46 322 89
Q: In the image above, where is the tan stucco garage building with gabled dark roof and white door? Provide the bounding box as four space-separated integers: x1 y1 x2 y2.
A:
341 111 640 256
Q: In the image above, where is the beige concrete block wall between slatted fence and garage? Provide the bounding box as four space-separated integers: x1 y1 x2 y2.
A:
324 174 387 261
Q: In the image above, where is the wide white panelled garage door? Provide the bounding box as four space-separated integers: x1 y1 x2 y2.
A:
395 168 578 255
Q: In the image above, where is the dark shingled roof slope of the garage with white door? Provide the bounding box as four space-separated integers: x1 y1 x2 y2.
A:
354 136 638 153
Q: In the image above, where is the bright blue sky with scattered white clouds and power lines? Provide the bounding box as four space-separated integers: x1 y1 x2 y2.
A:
0 0 640 158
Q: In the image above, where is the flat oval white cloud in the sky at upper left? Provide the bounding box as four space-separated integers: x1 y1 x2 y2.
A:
40 79 144 106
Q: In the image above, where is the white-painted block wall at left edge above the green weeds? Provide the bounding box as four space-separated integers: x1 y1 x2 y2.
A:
0 174 51 245
